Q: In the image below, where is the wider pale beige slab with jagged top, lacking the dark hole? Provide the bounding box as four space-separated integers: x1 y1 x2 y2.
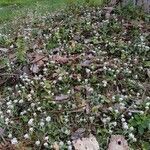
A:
72 134 99 150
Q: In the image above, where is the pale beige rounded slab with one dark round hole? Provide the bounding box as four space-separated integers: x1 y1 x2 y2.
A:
108 135 129 150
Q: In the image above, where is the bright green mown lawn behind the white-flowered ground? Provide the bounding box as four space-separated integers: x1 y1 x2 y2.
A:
0 0 106 24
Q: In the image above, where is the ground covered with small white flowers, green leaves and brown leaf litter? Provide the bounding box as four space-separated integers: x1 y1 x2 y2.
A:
0 2 150 150
